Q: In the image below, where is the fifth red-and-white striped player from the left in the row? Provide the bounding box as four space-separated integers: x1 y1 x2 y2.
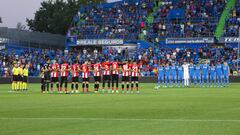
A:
92 62 101 93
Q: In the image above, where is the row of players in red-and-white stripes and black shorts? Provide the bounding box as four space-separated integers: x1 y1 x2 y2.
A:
41 59 140 93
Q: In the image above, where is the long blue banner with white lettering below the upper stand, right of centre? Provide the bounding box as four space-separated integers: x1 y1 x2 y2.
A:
166 37 214 44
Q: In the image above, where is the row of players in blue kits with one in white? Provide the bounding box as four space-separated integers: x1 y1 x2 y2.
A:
157 61 229 88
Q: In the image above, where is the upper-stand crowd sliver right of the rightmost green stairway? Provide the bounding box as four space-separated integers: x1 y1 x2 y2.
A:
224 0 240 37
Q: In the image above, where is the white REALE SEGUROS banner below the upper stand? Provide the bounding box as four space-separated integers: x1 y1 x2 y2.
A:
77 39 123 45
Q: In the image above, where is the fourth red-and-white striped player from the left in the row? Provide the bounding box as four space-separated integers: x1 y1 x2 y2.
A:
80 61 89 92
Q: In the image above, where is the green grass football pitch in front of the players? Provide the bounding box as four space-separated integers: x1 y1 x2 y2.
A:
0 83 240 135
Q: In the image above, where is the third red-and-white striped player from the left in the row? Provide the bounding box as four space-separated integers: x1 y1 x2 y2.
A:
71 60 79 93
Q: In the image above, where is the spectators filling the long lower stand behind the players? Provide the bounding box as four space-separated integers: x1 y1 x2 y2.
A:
0 46 240 76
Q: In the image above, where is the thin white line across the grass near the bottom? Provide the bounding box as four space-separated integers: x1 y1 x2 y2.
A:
0 117 240 122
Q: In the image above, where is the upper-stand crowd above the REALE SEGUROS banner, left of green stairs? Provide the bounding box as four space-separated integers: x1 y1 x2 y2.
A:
68 0 154 40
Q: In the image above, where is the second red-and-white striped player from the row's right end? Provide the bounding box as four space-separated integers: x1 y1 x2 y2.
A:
122 62 130 93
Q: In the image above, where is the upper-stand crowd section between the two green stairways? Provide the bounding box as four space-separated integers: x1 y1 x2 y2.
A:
147 0 226 41
